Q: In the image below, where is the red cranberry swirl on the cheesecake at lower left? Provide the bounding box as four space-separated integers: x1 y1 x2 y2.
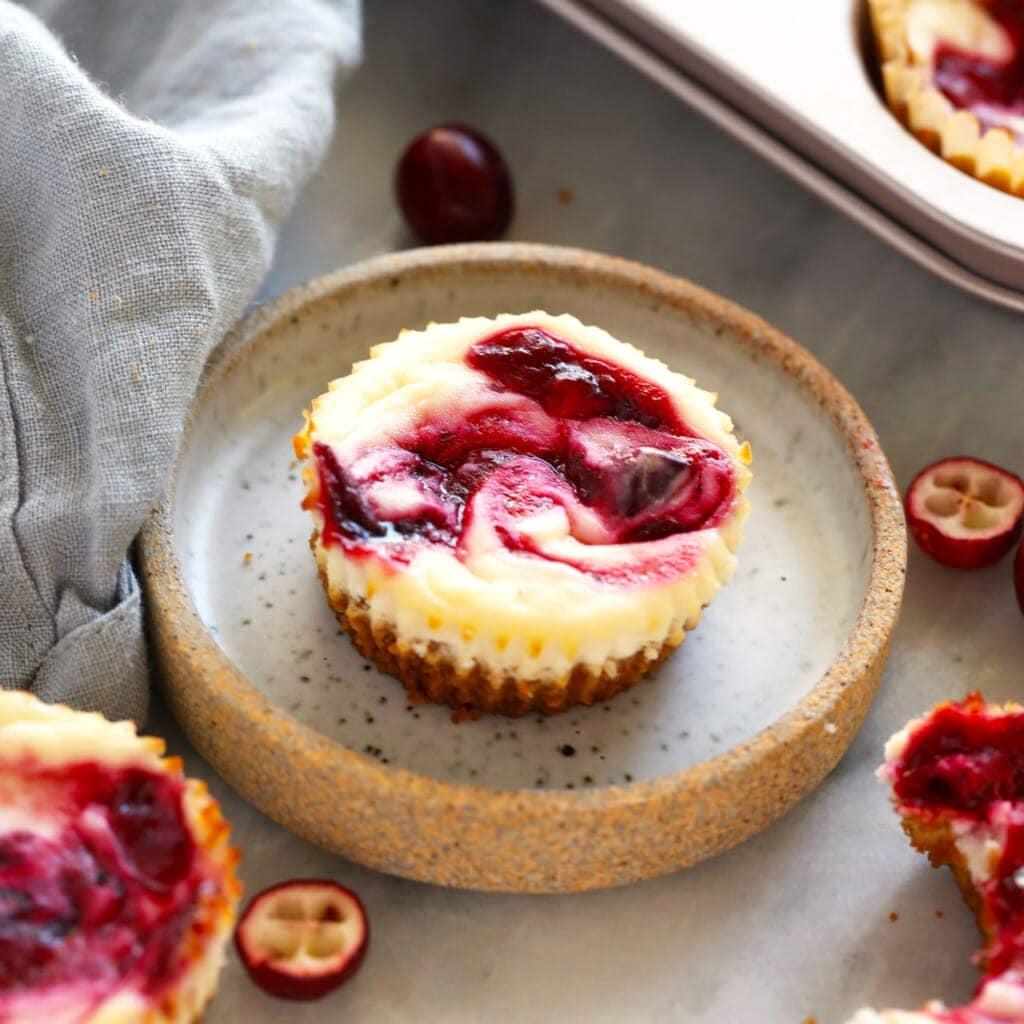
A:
0 763 203 1007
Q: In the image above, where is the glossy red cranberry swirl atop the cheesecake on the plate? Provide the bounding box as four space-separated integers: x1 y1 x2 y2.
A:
312 327 736 586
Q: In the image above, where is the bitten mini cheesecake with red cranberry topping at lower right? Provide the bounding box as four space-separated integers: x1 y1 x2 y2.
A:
851 694 1024 1024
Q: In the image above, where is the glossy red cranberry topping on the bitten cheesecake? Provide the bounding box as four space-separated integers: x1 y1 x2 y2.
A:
885 694 1024 1024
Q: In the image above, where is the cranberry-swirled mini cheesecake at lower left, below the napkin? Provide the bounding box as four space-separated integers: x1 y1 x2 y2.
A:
0 691 240 1024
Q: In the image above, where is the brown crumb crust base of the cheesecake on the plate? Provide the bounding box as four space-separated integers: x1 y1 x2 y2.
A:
309 529 681 722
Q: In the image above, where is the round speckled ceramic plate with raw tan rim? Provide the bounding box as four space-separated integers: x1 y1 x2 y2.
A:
142 245 906 891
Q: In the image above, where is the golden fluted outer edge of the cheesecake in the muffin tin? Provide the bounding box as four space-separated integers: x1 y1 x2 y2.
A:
868 0 1024 197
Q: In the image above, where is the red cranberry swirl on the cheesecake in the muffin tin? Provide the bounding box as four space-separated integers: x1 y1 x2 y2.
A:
933 0 1024 122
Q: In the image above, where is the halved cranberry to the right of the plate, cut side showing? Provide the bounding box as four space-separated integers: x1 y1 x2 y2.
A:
905 458 1024 569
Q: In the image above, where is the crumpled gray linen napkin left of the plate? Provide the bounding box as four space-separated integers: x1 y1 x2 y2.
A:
0 0 358 721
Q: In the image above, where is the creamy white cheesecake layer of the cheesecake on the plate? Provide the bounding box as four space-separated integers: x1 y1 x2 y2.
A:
299 312 751 680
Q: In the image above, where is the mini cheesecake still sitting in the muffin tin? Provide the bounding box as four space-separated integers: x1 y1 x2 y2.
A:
869 0 1024 196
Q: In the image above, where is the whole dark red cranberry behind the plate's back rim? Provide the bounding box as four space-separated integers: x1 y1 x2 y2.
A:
394 125 514 245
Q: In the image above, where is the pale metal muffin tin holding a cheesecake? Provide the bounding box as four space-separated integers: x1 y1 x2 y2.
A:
541 0 1024 311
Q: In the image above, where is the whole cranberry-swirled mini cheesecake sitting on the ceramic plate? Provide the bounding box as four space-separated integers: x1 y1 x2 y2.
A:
295 312 751 716
